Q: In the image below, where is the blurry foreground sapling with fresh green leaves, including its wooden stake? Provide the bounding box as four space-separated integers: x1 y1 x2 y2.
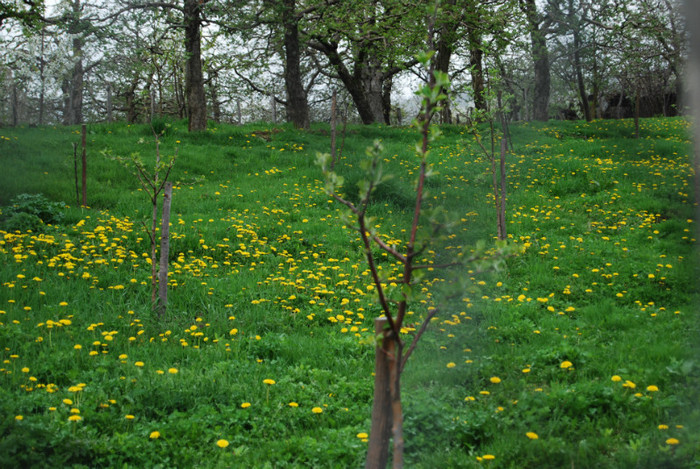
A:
317 9 512 468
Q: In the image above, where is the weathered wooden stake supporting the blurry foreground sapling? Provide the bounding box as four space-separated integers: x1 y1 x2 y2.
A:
365 317 395 469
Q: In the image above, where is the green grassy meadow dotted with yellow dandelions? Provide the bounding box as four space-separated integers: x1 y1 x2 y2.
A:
0 119 700 468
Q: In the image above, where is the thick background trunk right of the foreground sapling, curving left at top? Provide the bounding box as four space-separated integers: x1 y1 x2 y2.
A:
520 0 551 121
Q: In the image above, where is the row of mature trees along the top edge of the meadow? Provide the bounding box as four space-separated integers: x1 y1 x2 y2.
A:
0 0 687 130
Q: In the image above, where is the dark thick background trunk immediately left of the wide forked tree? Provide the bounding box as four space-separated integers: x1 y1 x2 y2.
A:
282 0 309 129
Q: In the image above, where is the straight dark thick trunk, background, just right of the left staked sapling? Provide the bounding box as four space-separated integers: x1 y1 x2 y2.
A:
183 0 207 131
